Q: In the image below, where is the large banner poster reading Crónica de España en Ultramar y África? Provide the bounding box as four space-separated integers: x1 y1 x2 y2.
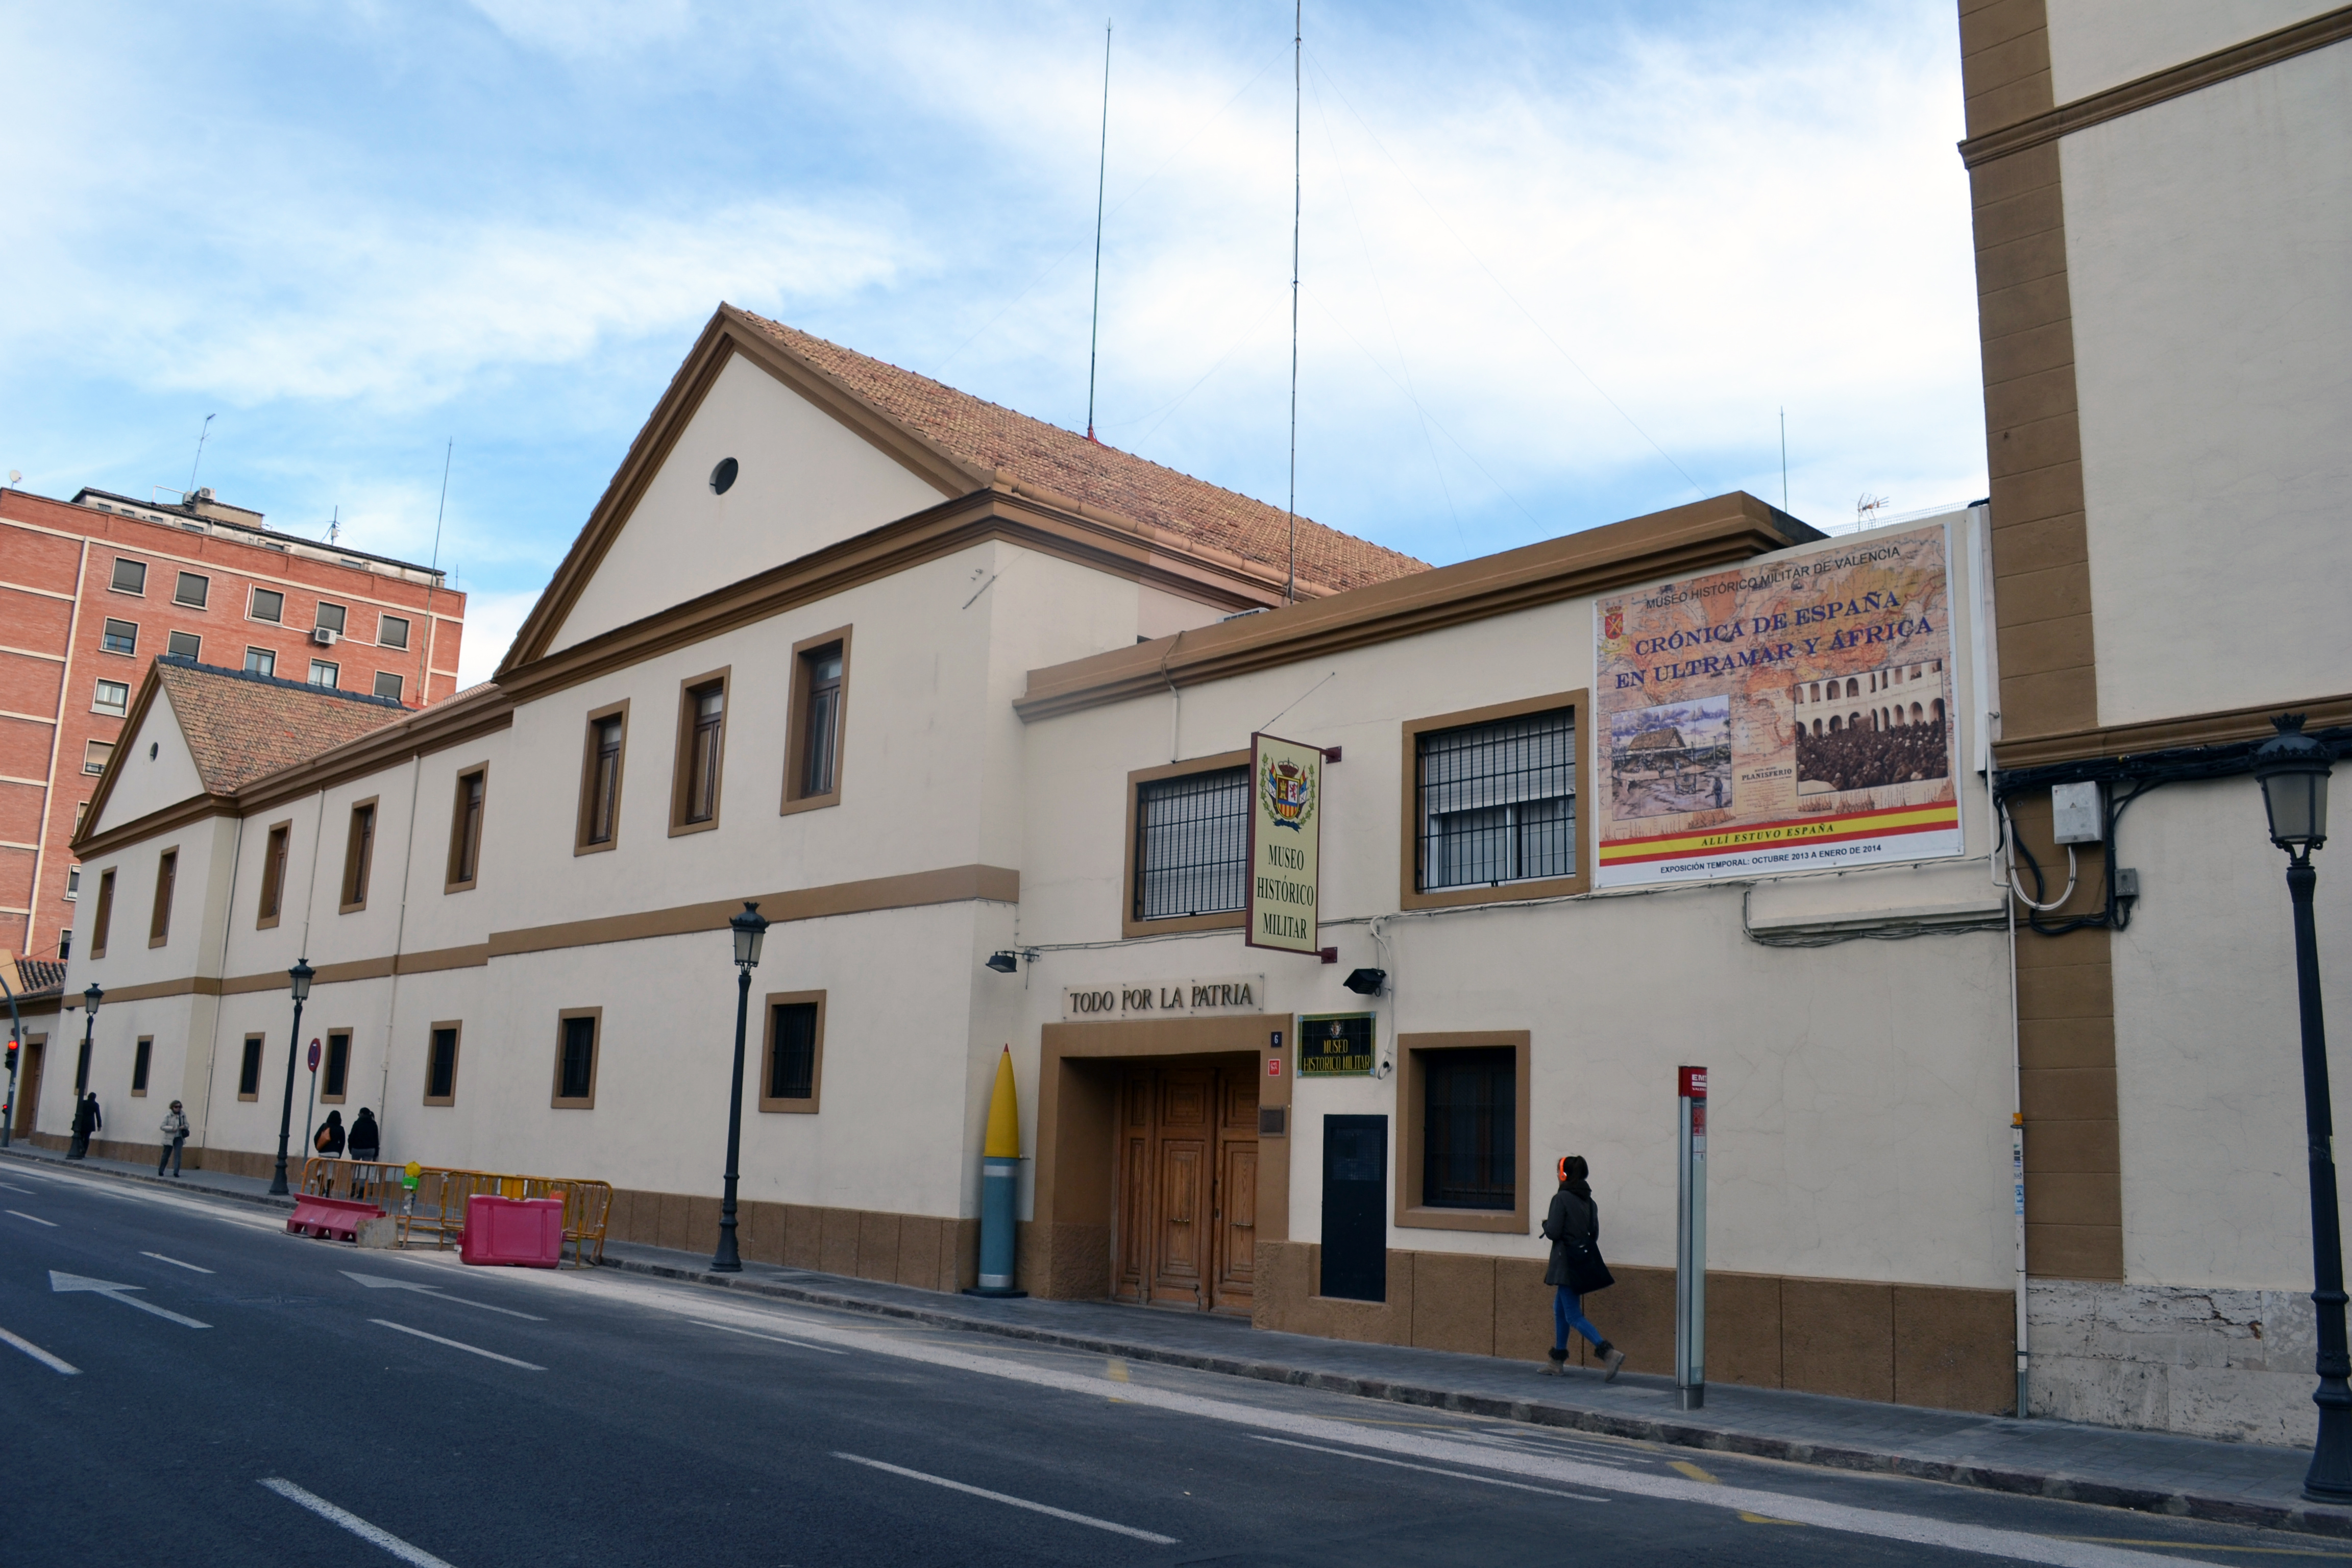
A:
1595 524 1962 886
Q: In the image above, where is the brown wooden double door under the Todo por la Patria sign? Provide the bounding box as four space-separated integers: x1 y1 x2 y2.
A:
1110 1056 1258 1314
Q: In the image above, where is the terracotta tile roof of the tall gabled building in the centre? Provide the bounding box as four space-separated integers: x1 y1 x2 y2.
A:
743 310 1430 593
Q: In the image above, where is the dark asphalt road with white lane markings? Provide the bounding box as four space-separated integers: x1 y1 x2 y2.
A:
0 1161 2352 1568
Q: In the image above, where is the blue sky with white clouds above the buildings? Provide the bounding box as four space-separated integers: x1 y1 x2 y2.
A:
0 0 1985 677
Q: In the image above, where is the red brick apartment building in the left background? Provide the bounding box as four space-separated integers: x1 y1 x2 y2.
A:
0 489 465 959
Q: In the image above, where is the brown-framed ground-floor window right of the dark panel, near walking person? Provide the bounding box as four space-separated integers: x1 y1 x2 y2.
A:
1397 1032 1529 1234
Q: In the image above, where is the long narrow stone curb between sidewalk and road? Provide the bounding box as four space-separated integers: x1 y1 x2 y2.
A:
602 1258 2352 1540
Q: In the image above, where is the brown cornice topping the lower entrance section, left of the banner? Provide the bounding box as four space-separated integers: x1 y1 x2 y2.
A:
1014 492 1821 722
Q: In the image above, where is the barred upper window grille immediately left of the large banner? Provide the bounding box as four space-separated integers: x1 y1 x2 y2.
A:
1418 707 1576 889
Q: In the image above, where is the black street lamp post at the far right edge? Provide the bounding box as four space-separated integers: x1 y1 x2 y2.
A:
2253 713 2352 1502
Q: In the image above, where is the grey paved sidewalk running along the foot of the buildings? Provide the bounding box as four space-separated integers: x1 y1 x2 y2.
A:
9 1145 2352 1537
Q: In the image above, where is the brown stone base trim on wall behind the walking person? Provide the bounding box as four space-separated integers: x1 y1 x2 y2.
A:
1254 1241 2016 1415
